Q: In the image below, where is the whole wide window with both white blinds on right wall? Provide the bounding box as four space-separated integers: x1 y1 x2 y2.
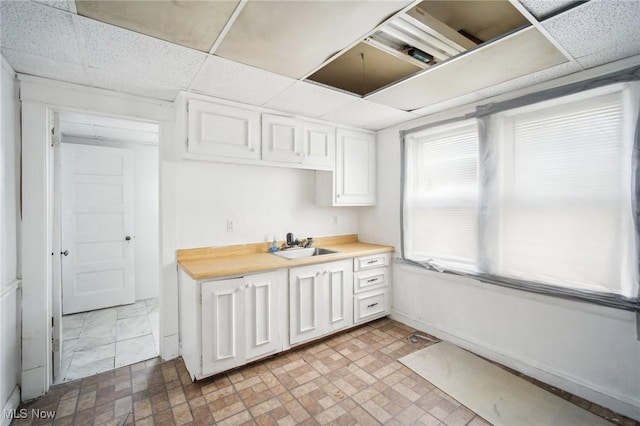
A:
403 83 640 300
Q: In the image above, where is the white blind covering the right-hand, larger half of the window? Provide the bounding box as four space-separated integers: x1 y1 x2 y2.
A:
491 92 633 295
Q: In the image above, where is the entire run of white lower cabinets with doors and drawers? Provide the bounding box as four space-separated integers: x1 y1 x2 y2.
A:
179 253 390 379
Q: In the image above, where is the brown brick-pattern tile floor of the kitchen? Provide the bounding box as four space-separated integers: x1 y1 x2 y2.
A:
13 318 639 426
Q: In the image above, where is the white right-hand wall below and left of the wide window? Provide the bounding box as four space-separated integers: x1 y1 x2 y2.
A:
360 95 640 419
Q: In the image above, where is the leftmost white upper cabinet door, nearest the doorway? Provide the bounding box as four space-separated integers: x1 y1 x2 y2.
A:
187 99 260 160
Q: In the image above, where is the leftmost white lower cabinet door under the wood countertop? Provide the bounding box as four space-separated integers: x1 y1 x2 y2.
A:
201 278 245 375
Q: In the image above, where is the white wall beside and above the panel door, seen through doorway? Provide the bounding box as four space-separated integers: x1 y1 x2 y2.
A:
62 136 160 300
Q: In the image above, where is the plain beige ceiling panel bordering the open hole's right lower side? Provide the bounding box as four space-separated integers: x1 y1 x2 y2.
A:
367 27 567 111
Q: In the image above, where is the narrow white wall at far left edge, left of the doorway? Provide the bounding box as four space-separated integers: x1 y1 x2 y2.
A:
0 57 21 425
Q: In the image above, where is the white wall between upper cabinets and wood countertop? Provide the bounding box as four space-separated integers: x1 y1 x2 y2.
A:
175 160 358 249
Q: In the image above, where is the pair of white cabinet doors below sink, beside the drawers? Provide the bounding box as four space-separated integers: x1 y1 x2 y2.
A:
289 260 353 345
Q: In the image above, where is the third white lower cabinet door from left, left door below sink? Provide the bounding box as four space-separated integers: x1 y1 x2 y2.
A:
289 265 324 344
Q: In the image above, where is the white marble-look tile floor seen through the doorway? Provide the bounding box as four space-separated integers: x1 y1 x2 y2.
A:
57 298 160 383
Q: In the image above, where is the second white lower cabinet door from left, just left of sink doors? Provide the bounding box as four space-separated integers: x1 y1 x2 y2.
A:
245 272 284 361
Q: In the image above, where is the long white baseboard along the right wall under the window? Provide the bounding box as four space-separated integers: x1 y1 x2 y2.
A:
391 312 640 421
